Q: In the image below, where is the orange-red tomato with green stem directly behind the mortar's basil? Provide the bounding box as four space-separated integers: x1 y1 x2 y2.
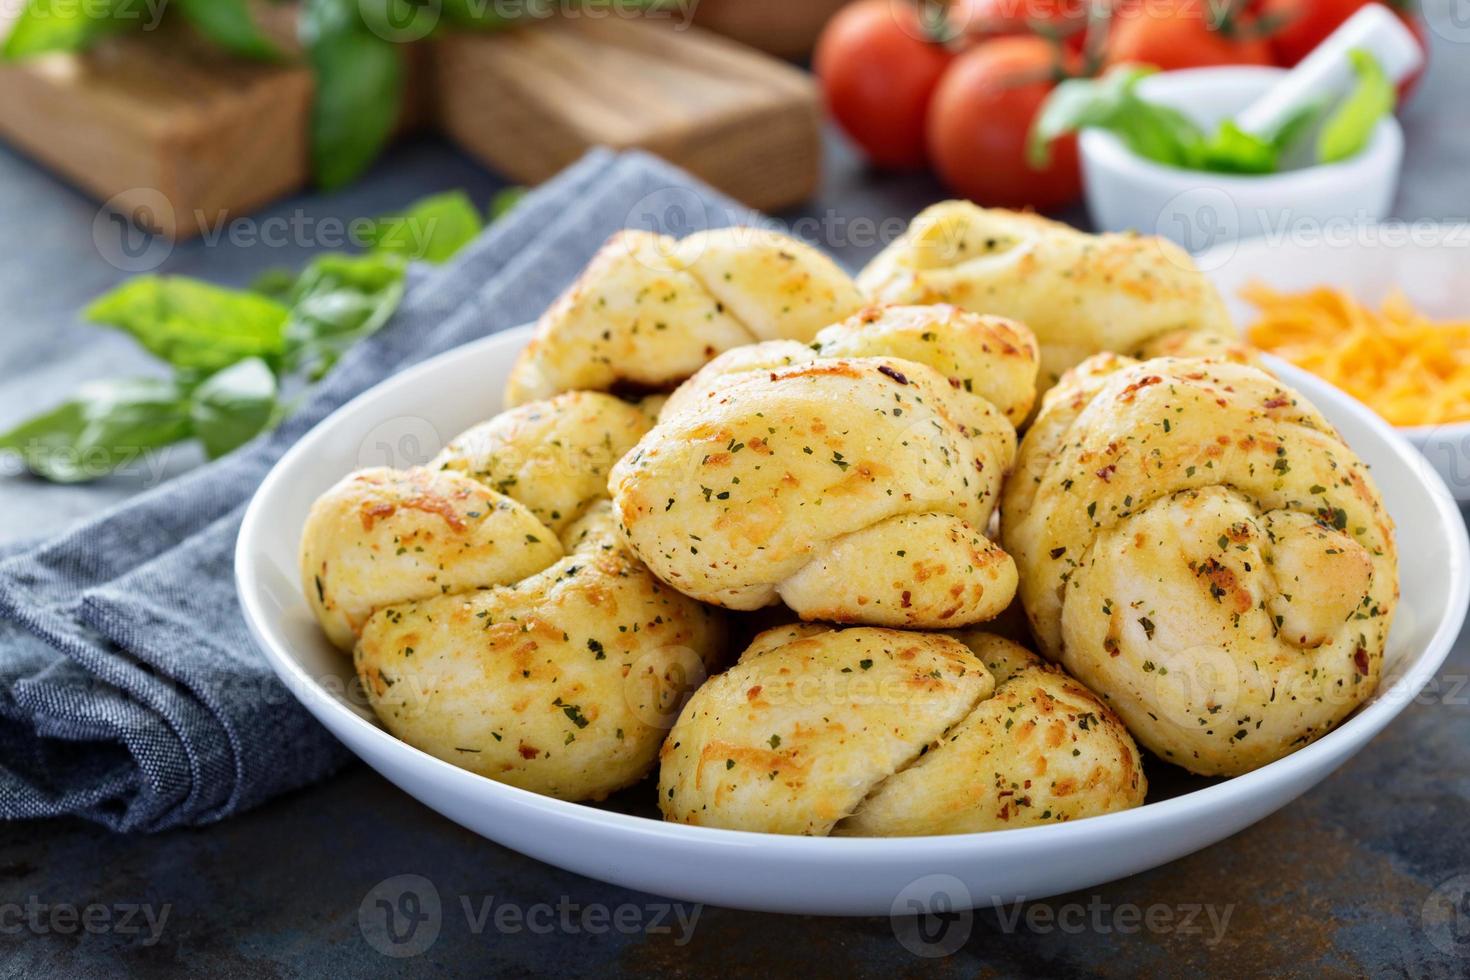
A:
1107 0 1274 72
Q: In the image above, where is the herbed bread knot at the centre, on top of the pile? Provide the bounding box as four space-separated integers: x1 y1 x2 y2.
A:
609 307 1035 627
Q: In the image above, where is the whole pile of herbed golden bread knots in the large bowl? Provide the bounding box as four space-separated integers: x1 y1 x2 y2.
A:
301 201 1398 836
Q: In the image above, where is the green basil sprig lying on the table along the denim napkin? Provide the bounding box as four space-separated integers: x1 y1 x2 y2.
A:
0 191 484 483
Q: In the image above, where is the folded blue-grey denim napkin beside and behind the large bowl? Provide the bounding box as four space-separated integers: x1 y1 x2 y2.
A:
0 151 753 830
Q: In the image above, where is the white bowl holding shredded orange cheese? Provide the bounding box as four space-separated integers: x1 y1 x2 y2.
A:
1195 222 1470 502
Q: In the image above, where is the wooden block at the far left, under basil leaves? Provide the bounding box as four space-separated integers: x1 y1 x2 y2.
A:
0 18 312 238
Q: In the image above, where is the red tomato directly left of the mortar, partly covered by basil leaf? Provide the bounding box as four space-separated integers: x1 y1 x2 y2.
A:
928 37 1082 209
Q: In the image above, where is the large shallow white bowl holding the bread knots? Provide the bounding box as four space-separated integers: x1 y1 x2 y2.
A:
235 328 1470 915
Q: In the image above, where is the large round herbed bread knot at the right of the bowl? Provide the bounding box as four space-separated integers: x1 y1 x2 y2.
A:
1001 356 1398 774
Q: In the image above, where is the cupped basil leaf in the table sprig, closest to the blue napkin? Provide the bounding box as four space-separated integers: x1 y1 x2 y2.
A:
285 253 404 378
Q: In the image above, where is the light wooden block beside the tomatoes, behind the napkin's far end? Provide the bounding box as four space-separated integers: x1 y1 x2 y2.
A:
435 16 822 210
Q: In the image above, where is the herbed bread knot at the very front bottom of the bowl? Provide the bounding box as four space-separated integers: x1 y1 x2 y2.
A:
659 624 1147 836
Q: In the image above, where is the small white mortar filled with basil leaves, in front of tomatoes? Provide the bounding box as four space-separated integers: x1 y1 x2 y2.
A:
1078 66 1404 251
